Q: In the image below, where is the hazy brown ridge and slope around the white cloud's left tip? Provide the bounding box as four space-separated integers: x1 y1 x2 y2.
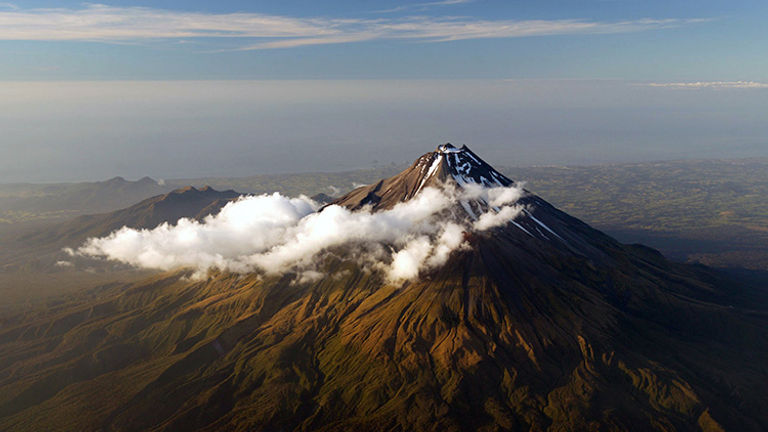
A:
0 187 240 310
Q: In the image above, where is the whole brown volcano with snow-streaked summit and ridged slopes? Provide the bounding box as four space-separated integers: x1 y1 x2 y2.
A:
0 144 768 431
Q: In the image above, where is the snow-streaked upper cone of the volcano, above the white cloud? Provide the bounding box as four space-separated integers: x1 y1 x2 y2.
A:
331 143 602 257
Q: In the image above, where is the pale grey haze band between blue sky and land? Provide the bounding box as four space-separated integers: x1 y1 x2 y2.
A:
0 80 768 183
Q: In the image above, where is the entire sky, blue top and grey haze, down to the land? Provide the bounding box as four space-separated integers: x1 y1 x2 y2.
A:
0 0 768 182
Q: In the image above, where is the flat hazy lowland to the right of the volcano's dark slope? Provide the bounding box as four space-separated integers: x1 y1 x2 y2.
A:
506 159 768 270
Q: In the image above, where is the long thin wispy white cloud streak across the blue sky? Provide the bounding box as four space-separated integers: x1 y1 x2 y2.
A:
0 4 707 50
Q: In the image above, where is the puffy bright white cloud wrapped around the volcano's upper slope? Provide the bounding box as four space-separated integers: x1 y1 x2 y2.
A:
78 186 523 283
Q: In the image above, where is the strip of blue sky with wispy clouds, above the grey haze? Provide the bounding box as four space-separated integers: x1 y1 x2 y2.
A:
0 0 768 81
